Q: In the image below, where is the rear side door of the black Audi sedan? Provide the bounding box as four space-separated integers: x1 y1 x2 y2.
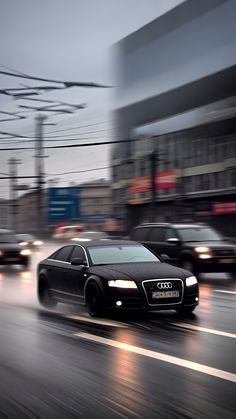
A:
50 245 74 296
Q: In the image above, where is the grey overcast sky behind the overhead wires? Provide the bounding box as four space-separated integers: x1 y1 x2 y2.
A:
0 0 181 198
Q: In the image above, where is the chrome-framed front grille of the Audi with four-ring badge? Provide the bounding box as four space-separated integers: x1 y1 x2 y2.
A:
142 278 184 306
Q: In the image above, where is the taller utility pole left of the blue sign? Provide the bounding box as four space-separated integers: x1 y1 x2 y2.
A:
35 114 47 232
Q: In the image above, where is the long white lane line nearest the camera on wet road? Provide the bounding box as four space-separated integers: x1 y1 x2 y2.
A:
74 332 236 383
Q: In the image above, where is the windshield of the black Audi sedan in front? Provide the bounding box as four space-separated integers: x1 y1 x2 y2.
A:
88 245 160 265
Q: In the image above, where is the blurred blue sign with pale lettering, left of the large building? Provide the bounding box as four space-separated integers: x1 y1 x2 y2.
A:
48 186 80 224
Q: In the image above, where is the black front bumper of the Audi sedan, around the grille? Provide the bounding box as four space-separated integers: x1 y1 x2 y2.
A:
104 280 199 310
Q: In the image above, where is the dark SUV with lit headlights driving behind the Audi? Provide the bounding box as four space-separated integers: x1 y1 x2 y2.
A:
130 223 236 277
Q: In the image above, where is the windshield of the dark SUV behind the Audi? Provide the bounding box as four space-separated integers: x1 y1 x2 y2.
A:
178 227 222 242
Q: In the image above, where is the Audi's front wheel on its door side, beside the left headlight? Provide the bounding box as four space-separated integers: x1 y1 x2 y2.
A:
85 281 104 317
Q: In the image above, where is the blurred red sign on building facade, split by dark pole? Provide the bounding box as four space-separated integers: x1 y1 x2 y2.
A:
129 170 176 194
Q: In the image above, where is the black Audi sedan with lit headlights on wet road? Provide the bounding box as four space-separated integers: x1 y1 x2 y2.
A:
37 240 199 316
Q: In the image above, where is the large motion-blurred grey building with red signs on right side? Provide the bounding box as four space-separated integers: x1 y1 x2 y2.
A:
112 0 236 236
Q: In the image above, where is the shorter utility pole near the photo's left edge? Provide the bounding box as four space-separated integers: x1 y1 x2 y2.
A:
8 157 21 231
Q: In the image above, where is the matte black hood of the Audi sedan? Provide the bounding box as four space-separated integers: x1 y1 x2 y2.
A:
89 262 192 282
